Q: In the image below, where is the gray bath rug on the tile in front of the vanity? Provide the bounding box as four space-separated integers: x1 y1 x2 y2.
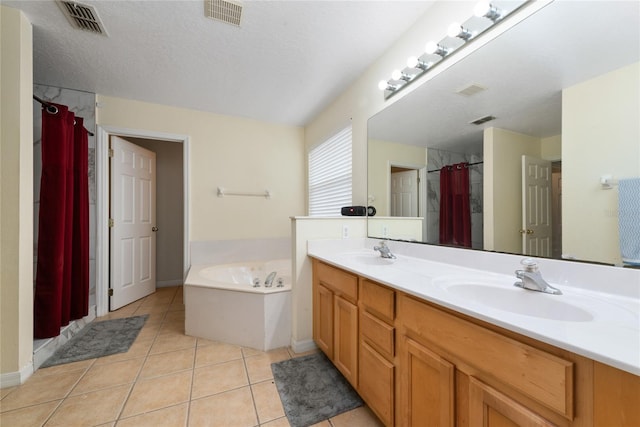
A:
271 352 362 427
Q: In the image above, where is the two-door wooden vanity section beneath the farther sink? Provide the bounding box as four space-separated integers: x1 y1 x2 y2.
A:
312 261 358 388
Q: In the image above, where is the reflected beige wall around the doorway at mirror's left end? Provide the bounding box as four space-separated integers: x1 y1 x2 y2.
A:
367 140 427 216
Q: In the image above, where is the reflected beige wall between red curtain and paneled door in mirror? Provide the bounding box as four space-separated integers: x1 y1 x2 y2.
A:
484 128 542 253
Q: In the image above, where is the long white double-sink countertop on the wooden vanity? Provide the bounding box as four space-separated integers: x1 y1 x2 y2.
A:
308 241 640 375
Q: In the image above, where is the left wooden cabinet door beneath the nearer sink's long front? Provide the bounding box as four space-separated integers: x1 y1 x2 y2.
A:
398 337 455 427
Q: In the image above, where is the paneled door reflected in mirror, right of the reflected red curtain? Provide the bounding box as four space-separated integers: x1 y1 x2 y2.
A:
520 156 552 257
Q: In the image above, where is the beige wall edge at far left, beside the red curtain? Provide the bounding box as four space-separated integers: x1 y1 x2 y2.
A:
0 6 33 387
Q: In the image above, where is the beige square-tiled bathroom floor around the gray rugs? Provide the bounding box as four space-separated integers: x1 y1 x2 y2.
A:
0 287 381 427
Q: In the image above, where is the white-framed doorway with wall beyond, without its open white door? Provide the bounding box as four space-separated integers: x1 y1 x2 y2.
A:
96 126 190 316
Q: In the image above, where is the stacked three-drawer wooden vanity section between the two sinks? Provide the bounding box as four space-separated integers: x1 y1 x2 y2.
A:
358 278 396 426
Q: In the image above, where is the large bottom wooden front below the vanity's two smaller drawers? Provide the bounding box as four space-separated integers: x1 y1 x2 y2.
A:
358 341 395 426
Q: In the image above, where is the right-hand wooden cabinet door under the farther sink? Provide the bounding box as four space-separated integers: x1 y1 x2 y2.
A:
333 295 358 388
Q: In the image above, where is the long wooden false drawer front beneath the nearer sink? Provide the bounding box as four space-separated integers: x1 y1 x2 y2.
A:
398 295 574 420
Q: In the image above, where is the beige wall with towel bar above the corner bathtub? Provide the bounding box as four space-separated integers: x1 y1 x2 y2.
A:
97 95 306 241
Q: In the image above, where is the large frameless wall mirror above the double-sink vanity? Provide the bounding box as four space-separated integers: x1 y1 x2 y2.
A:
368 0 640 265
